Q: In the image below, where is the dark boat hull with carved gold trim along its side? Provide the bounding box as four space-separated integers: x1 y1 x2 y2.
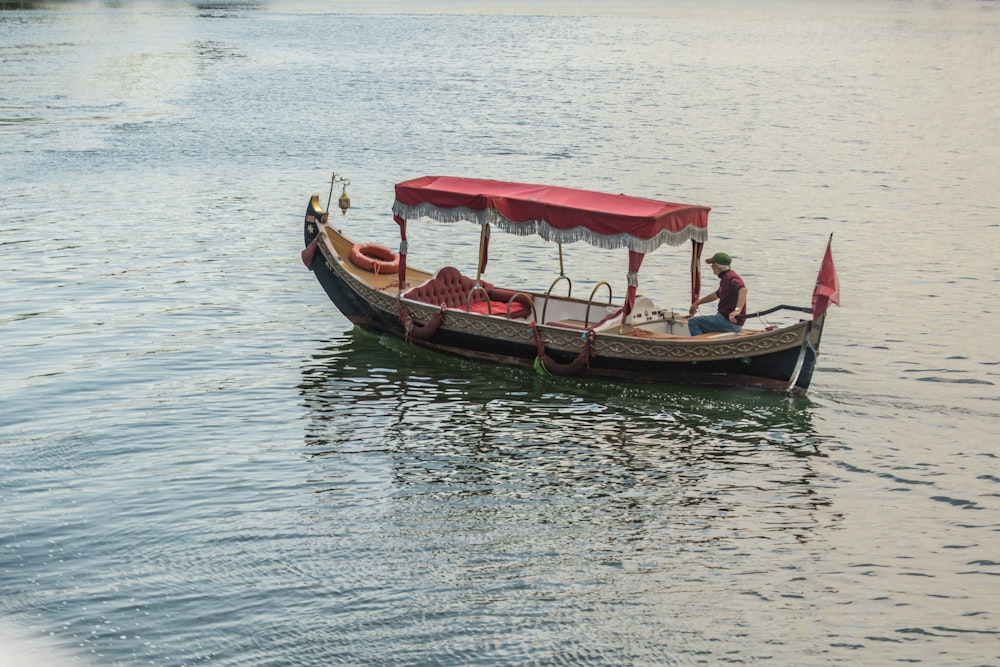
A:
305 211 822 393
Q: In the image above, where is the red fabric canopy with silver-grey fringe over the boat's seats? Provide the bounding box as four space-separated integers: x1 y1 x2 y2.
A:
392 176 710 254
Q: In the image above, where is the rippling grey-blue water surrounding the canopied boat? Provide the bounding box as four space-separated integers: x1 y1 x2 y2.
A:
0 0 1000 665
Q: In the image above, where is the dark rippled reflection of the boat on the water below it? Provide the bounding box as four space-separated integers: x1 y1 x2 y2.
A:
301 329 833 542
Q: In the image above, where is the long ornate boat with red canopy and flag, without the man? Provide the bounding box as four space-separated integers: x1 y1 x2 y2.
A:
302 173 839 394
